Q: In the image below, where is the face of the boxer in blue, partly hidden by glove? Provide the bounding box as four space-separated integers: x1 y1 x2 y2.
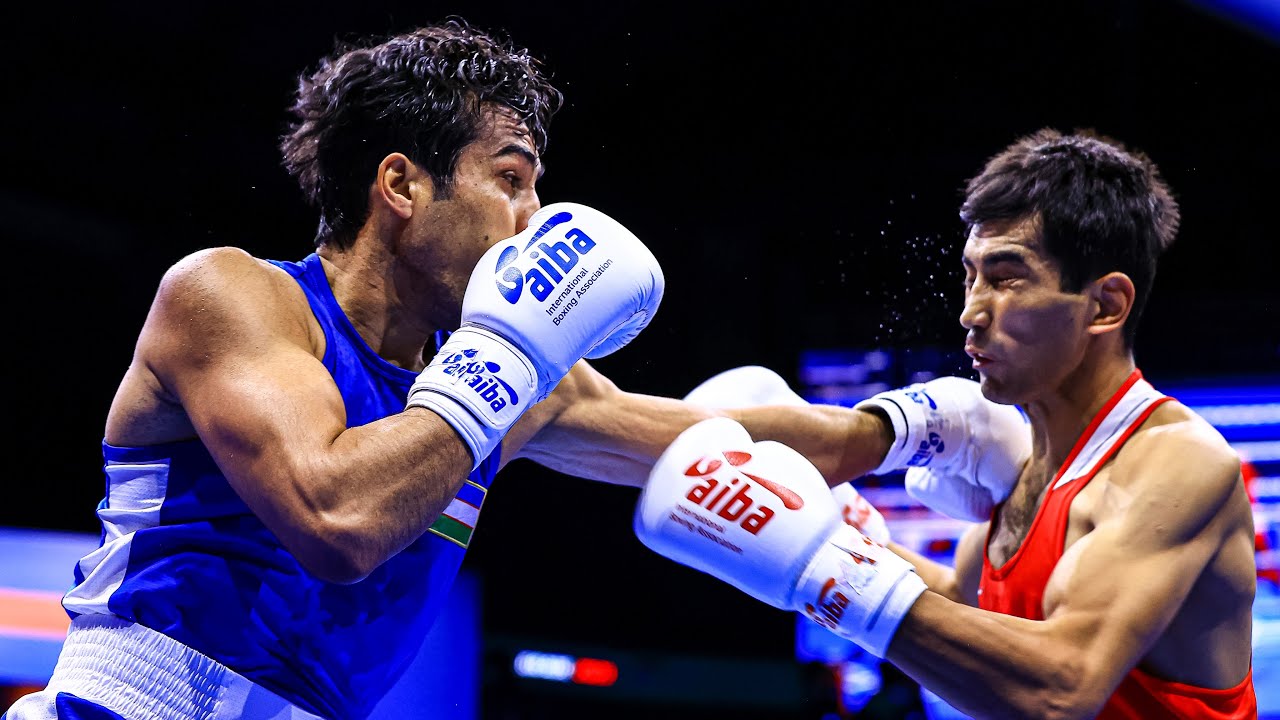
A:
411 106 543 327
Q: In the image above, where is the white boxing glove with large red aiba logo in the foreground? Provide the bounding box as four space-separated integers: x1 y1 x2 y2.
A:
635 418 925 657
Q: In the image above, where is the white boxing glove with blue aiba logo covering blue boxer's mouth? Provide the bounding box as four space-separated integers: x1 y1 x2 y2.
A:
408 202 664 466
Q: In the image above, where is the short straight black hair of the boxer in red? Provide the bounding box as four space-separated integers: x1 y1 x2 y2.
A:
960 128 1179 348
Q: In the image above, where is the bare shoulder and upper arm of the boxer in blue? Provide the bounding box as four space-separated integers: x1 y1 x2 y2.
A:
140 249 346 515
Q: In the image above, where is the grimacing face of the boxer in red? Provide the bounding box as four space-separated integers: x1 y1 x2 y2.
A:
960 215 1089 404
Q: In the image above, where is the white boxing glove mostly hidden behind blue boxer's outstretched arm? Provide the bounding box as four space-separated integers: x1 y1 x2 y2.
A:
684 365 890 544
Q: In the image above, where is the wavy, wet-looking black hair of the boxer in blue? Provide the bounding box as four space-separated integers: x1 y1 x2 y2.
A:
280 18 563 247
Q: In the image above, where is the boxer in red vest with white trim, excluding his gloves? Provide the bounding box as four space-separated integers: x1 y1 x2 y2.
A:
888 131 1257 719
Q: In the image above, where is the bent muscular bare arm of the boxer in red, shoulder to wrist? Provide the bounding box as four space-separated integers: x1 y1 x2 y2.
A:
888 427 1239 717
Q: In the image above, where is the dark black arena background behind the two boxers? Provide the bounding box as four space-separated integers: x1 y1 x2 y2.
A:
0 0 1280 712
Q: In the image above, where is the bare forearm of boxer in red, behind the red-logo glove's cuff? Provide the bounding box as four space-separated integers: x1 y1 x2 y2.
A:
887 592 1097 719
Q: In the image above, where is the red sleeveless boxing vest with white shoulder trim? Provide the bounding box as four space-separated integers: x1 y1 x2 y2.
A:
978 370 1258 720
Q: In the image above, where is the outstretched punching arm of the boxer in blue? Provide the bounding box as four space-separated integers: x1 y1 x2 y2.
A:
503 361 892 487
